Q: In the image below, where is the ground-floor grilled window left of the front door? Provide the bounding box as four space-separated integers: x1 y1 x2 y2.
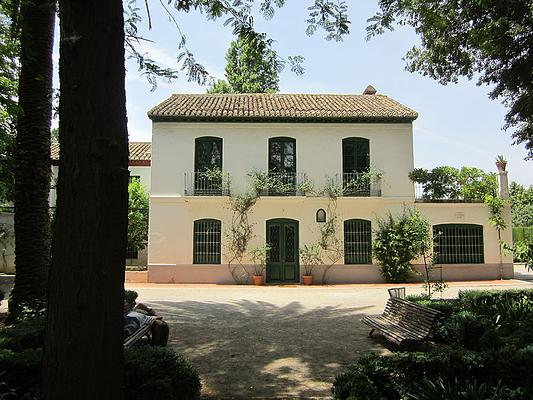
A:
193 219 221 264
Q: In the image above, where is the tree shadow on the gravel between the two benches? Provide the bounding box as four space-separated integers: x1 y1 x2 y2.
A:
150 300 386 399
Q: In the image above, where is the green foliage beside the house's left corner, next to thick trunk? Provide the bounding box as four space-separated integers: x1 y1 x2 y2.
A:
128 179 149 250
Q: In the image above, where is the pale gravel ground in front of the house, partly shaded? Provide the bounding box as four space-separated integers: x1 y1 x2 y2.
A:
128 280 531 399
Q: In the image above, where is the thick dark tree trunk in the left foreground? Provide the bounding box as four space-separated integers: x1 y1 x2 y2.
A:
43 0 128 400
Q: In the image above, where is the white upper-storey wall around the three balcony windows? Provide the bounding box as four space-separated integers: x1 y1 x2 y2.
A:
152 122 414 198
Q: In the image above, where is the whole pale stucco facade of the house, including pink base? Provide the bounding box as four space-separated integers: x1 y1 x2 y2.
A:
148 122 512 284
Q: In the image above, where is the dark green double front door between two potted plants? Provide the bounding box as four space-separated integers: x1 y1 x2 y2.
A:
266 219 300 283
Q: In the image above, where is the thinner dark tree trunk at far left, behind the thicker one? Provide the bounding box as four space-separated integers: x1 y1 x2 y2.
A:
9 0 55 318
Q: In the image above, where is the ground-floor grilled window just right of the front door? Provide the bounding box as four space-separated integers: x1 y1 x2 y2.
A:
344 219 372 264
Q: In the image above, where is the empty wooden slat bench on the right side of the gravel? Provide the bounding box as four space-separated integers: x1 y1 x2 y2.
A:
361 297 441 346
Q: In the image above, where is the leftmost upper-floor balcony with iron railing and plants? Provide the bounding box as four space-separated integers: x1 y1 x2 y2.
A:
185 170 230 196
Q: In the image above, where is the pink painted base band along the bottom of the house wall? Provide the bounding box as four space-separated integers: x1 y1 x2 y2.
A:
148 263 514 285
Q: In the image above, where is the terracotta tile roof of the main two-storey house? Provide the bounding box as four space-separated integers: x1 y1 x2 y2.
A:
148 93 418 122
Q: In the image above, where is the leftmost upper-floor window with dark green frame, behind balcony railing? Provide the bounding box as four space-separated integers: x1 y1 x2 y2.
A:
194 136 222 196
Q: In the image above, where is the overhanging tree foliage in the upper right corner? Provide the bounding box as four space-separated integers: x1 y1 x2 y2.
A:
367 0 533 157
